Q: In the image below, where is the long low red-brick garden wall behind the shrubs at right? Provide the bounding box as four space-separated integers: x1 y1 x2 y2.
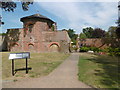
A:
79 38 120 49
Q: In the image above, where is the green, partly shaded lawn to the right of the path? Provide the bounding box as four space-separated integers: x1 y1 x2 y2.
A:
78 53 120 89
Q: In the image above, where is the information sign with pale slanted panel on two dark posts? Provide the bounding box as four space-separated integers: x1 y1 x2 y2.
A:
9 52 30 76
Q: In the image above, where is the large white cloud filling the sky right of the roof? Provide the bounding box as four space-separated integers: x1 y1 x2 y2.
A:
39 0 118 33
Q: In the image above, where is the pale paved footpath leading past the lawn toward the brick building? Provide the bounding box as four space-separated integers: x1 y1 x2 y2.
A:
3 53 91 88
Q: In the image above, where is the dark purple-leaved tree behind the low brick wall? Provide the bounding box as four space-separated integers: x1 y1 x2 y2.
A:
92 28 105 38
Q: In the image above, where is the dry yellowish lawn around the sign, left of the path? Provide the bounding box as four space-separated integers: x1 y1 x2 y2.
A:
0 52 70 80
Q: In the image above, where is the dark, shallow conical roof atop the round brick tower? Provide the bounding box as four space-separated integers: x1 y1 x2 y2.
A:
20 14 54 22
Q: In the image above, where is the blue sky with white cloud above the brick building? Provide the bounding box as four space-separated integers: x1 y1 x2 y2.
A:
0 0 118 33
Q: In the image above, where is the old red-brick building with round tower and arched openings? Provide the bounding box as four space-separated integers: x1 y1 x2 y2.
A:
7 14 71 53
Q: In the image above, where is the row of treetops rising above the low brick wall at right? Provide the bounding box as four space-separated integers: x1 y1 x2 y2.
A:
80 26 120 38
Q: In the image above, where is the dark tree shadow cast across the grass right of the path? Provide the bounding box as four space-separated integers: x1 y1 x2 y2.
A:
87 56 120 88
